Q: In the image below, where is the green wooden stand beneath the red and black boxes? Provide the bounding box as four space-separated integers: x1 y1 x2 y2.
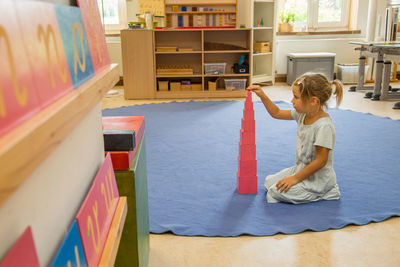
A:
115 136 150 267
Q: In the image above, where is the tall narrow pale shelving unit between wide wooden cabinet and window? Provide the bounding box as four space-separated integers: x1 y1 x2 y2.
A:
250 0 276 84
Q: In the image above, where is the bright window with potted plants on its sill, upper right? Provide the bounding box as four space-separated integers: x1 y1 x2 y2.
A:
280 0 350 30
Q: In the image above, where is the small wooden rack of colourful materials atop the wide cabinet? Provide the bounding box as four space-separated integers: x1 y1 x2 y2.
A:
165 0 237 28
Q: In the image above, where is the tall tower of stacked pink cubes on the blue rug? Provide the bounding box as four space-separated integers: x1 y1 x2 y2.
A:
237 91 257 194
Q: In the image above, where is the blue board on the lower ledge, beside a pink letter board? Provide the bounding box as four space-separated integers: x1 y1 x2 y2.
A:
51 220 87 267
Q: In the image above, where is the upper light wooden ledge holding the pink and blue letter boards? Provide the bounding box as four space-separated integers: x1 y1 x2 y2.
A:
0 64 119 205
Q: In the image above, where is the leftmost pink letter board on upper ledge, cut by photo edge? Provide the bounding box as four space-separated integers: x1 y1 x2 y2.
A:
0 0 39 137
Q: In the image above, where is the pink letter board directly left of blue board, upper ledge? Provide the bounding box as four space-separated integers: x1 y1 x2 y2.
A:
16 1 73 108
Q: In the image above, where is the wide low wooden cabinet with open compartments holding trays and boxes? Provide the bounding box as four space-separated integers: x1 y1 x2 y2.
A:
121 29 253 99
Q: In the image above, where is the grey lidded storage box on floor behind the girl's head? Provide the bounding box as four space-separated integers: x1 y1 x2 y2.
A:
286 52 336 85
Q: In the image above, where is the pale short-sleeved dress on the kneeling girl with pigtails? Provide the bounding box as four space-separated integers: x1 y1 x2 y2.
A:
264 110 340 204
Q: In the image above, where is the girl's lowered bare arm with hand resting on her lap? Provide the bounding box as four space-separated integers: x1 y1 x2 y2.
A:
276 146 329 193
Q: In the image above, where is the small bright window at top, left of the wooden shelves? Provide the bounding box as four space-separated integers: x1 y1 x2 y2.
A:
98 0 127 32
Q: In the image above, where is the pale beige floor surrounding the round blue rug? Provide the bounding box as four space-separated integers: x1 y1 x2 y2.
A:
102 83 400 267
